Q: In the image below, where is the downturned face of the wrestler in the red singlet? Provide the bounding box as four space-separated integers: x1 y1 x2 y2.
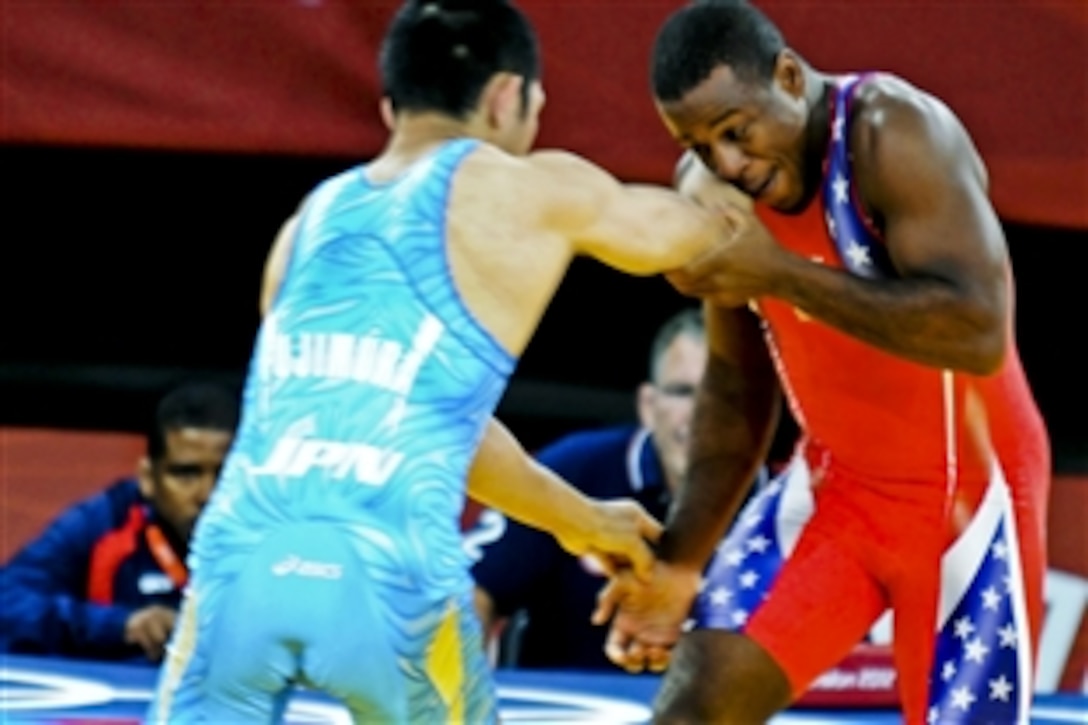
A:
657 57 807 211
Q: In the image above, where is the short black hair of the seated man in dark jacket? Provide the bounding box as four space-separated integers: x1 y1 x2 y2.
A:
147 381 238 460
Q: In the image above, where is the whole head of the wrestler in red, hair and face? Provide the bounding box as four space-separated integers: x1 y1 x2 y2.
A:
652 0 818 211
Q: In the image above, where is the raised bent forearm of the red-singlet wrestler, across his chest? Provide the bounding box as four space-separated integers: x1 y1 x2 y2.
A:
772 252 1007 374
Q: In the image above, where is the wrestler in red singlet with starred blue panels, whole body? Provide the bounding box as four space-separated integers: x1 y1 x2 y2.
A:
598 0 1050 725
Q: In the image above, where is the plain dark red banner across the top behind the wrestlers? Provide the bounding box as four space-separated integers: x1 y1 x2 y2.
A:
0 0 1088 229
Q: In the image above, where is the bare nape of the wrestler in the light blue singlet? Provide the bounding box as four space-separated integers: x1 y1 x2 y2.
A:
368 112 489 181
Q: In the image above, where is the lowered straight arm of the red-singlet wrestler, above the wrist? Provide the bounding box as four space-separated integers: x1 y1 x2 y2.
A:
659 335 779 570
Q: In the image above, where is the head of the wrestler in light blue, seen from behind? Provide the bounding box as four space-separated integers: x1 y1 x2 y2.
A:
381 0 544 153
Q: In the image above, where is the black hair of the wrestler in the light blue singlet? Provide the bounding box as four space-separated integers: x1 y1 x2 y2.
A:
380 0 540 119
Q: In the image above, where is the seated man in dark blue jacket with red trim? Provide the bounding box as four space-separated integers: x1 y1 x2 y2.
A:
0 383 238 663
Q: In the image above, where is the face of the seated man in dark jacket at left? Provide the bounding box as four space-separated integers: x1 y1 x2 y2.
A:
140 428 233 541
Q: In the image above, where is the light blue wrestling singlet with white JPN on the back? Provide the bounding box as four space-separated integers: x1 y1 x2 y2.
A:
145 139 515 723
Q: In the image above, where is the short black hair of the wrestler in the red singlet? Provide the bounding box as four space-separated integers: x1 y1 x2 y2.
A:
651 0 786 102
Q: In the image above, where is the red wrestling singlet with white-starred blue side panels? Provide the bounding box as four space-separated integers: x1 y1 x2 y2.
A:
694 77 1050 723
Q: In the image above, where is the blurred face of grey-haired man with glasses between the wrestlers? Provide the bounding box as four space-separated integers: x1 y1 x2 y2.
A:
639 333 706 491
